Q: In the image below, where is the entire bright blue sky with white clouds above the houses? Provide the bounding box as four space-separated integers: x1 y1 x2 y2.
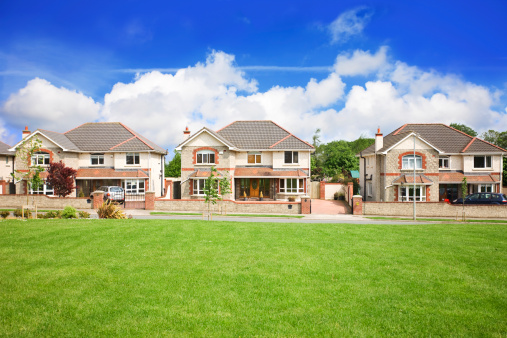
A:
0 0 507 152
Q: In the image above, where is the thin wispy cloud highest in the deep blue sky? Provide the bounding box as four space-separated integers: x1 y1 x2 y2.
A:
328 7 372 43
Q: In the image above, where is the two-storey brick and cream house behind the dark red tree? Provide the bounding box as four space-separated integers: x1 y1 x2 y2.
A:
10 122 167 197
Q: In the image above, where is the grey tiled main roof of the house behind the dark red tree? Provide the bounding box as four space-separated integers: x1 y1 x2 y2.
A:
64 122 166 154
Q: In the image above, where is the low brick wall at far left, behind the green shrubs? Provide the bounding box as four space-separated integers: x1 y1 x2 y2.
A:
0 195 93 209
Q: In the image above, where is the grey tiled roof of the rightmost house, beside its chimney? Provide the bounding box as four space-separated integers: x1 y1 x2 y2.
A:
362 123 507 155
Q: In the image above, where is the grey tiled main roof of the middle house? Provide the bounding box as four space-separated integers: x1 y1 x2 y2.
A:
217 121 314 150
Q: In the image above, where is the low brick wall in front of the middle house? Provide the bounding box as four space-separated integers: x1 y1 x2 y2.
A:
155 199 301 214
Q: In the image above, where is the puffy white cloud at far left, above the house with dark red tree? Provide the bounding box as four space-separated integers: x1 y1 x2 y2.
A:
2 78 101 131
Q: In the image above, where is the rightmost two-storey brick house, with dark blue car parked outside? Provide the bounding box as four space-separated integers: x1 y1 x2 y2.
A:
358 124 507 202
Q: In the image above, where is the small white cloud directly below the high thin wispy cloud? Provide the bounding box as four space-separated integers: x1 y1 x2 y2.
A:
334 46 387 76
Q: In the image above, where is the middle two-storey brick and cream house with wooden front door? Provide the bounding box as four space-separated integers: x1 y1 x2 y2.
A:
176 121 315 201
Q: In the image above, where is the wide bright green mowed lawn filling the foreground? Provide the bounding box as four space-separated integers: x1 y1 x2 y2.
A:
0 220 507 337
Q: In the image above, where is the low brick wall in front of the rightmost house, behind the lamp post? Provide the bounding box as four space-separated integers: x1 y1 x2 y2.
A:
363 202 507 218
